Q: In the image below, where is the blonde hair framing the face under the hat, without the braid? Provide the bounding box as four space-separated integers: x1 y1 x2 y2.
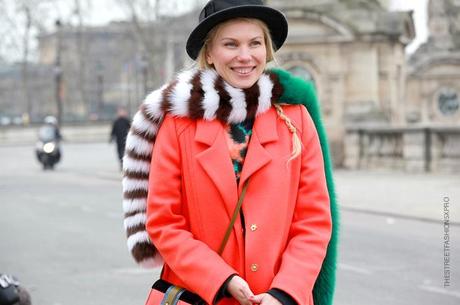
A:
196 18 276 69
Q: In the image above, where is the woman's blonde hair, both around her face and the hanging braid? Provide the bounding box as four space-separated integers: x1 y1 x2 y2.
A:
196 18 302 162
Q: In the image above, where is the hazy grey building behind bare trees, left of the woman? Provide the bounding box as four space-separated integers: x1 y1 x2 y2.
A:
0 12 196 122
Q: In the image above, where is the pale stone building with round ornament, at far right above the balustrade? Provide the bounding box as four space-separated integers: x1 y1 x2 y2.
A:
406 0 460 126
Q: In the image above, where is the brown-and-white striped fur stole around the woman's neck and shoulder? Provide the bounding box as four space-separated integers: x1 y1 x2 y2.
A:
123 70 283 267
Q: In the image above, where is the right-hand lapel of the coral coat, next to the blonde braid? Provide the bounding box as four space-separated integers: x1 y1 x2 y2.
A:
238 109 278 194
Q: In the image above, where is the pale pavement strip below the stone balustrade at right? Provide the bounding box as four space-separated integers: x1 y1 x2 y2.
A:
334 170 460 225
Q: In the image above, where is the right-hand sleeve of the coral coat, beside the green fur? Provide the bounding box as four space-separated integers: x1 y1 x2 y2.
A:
271 106 332 305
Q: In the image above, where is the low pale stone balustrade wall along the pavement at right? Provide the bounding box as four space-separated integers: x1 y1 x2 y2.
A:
345 127 460 173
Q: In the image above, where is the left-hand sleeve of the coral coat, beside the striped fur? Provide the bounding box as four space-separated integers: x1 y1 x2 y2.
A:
146 116 237 304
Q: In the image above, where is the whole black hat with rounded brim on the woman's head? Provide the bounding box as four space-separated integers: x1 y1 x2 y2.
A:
186 0 288 59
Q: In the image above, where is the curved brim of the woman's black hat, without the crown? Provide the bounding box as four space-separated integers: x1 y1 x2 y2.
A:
186 5 288 60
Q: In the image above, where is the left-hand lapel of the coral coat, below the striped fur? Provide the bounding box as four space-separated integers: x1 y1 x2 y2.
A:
195 120 238 219
